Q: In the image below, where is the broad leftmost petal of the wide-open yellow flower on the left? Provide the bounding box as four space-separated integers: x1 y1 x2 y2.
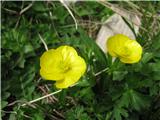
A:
40 49 64 80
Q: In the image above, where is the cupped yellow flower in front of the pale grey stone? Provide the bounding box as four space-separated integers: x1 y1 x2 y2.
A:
107 34 142 63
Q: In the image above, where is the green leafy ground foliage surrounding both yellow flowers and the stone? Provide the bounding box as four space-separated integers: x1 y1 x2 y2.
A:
1 1 160 120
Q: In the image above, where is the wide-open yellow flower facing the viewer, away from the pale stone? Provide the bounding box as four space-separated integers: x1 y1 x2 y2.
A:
40 46 86 88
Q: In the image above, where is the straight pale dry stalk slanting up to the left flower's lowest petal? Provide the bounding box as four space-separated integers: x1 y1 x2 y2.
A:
21 90 62 106
